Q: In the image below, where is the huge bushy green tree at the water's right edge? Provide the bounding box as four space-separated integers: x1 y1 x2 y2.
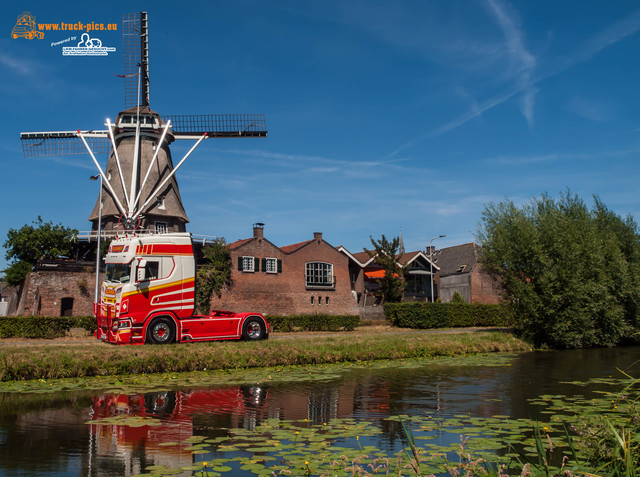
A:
477 192 640 348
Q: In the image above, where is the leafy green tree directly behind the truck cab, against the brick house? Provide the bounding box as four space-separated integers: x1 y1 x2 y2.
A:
196 238 231 313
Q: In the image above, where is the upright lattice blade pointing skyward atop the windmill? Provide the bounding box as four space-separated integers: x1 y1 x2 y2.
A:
122 12 149 109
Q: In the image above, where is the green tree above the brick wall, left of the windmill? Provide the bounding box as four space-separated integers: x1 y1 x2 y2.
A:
4 216 78 285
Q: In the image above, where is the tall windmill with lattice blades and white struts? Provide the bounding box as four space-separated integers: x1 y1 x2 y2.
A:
20 12 267 233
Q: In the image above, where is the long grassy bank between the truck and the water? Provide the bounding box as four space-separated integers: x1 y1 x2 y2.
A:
0 331 531 381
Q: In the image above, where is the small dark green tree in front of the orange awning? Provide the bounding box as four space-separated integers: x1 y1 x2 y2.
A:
364 234 407 303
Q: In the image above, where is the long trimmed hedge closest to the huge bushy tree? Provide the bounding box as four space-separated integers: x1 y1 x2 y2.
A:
384 302 511 329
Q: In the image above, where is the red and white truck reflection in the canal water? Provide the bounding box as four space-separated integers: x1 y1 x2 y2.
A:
89 385 269 475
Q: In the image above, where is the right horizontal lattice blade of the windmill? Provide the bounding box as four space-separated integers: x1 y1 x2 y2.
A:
162 114 267 139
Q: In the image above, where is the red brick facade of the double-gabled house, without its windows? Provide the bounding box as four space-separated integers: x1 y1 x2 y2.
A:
211 237 358 315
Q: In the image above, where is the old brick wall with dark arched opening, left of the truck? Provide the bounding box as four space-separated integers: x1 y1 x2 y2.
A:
16 270 97 316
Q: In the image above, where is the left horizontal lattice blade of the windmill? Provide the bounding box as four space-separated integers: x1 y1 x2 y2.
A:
20 131 111 157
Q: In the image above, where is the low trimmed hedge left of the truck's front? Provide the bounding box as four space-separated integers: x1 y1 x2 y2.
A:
0 316 97 339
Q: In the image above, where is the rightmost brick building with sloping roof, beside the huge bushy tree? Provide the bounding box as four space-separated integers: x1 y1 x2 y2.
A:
438 243 501 304
